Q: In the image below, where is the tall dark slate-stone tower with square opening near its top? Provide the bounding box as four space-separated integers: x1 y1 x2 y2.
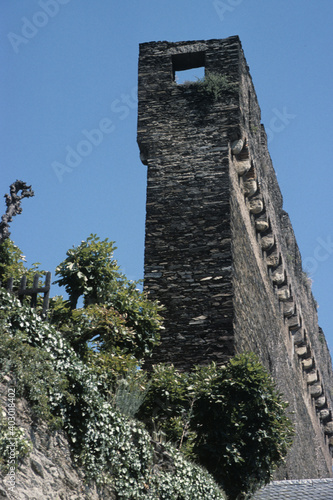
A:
138 37 333 479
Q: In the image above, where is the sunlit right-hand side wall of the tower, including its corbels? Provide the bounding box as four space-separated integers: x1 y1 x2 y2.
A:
230 46 333 479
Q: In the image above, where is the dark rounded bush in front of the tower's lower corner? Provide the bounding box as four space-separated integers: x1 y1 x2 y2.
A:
191 353 292 499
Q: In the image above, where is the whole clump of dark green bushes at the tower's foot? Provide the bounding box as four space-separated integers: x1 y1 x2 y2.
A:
140 353 292 499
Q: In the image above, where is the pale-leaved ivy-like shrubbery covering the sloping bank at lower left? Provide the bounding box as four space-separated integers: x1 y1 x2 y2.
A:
0 290 225 500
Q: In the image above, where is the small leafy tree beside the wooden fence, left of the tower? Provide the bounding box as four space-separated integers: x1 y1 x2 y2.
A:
51 234 162 360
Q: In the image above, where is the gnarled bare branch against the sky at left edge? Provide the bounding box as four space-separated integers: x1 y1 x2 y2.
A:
0 180 35 245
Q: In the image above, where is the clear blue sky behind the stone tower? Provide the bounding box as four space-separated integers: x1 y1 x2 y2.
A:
0 0 333 350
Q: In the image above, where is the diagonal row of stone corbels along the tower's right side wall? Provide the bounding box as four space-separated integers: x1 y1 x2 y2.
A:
231 139 333 447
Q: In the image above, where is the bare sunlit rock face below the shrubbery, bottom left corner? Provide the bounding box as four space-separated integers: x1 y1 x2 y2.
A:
0 383 116 500
